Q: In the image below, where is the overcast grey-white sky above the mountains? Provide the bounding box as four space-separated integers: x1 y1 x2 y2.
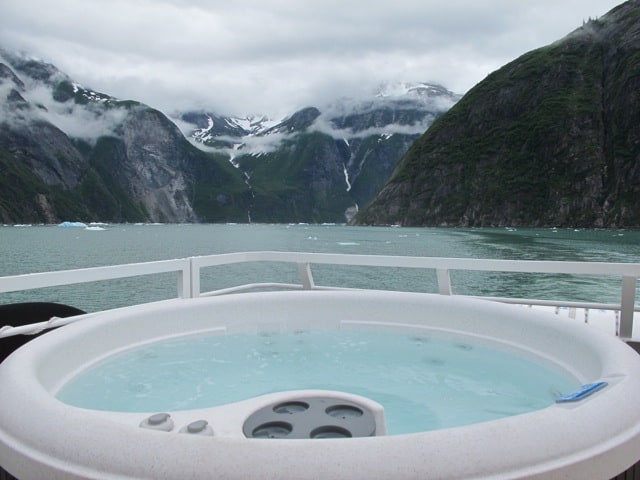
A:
0 0 623 118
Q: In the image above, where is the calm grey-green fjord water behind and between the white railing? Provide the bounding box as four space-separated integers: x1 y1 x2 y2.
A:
0 224 640 311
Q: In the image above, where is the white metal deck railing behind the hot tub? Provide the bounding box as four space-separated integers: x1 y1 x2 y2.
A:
0 252 640 339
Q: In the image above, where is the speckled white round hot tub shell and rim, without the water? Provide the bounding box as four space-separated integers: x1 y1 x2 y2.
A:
0 291 640 480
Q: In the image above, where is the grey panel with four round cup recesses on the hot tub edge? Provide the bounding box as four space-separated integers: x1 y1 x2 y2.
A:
243 397 376 439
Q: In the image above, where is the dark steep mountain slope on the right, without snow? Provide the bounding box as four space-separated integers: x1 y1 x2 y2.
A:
357 0 640 227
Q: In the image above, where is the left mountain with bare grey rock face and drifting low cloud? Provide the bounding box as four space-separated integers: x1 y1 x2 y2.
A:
0 47 251 223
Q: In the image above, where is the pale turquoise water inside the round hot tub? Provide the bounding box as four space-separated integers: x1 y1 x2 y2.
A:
57 329 580 434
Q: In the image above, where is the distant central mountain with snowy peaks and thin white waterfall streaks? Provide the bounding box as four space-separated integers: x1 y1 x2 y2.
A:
179 83 459 222
